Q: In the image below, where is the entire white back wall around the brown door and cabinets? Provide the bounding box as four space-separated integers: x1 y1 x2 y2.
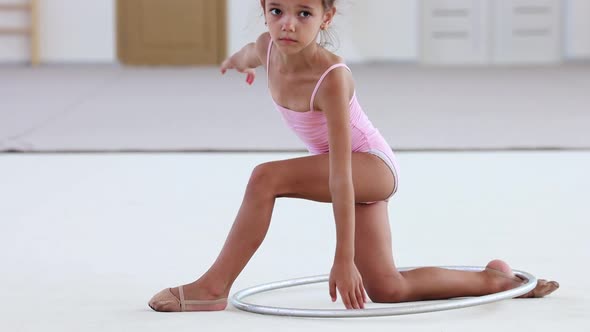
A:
0 0 590 63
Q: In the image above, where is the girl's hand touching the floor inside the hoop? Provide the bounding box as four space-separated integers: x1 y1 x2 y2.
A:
330 262 367 309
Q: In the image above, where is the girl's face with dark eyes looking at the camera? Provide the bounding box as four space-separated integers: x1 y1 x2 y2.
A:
261 0 336 54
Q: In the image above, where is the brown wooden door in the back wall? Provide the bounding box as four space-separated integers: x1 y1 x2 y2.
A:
117 0 227 65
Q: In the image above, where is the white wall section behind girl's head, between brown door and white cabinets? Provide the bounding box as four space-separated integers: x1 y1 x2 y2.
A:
229 0 418 62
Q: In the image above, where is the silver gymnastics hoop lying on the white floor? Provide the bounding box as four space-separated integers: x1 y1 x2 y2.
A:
231 266 537 318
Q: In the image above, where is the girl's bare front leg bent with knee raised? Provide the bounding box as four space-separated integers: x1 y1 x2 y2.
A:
150 153 394 310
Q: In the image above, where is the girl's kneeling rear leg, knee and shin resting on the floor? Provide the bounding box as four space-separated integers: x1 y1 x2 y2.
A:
355 202 559 302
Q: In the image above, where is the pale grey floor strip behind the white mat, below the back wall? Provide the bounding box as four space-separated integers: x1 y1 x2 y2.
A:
0 64 590 152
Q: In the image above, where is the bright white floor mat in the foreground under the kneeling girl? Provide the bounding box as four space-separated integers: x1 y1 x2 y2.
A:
0 151 590 332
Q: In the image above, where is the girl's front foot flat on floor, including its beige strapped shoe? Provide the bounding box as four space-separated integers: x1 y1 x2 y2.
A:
148 282 227 312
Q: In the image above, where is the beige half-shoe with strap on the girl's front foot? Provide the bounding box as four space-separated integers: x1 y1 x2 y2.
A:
148 286 227 312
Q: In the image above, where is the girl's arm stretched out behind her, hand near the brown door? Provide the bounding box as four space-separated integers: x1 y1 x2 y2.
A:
221 32 270 85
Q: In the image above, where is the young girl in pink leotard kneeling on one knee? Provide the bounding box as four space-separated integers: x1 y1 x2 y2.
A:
149 0 559 311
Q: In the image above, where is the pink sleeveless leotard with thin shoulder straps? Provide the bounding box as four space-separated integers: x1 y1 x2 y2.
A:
266 40 398 195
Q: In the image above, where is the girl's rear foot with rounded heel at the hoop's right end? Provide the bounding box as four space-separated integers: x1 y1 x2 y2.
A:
484 259 559 298
